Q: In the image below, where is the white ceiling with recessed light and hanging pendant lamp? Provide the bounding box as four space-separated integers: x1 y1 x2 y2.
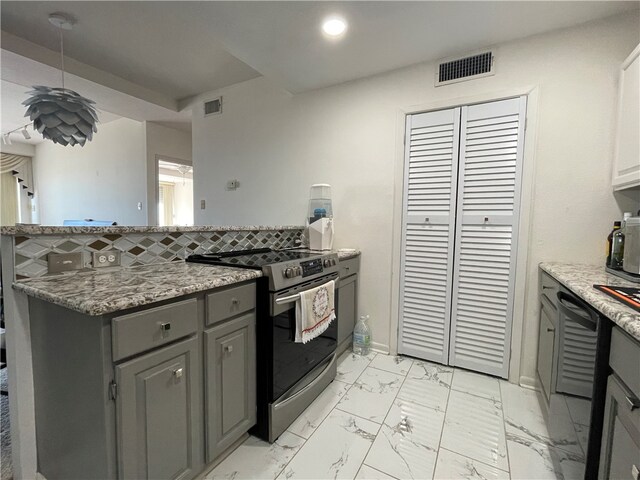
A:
0 0 640 142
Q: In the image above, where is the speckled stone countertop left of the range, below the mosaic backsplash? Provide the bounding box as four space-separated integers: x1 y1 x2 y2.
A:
13 262 262 315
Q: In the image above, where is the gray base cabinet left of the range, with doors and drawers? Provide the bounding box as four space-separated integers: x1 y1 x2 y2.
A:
29 282 256 480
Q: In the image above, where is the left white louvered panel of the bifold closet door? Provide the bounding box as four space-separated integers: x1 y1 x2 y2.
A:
398 108 460 363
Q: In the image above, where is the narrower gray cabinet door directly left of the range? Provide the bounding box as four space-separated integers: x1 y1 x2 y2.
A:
204 313 256 462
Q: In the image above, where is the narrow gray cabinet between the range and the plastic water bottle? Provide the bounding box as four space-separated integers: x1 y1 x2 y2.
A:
336 257 360 355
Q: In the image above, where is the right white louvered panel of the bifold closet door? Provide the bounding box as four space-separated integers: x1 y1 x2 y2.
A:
449 97 526 378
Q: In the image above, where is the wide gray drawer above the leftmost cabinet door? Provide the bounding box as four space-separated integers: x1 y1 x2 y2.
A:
111 298 198 361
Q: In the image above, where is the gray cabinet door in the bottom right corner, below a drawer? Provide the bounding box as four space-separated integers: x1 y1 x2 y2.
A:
599 375 640 480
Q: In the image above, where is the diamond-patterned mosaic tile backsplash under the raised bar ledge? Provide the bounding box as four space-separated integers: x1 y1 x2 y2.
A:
14 228 303 280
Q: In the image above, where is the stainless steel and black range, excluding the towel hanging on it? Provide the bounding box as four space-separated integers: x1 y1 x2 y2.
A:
187 249 339 442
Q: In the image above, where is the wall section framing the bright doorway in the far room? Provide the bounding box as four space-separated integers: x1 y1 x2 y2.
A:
145 122 191 225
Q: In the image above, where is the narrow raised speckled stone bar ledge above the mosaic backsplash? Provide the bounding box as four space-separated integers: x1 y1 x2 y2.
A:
0 225 304 235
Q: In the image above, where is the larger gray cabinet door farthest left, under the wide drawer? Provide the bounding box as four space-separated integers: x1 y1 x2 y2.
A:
116 338 201 480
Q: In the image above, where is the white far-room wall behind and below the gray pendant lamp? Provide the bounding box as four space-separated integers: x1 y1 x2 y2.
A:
33 118 147 225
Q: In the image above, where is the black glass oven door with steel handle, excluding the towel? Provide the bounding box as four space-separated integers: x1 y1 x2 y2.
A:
269 273 338 402
